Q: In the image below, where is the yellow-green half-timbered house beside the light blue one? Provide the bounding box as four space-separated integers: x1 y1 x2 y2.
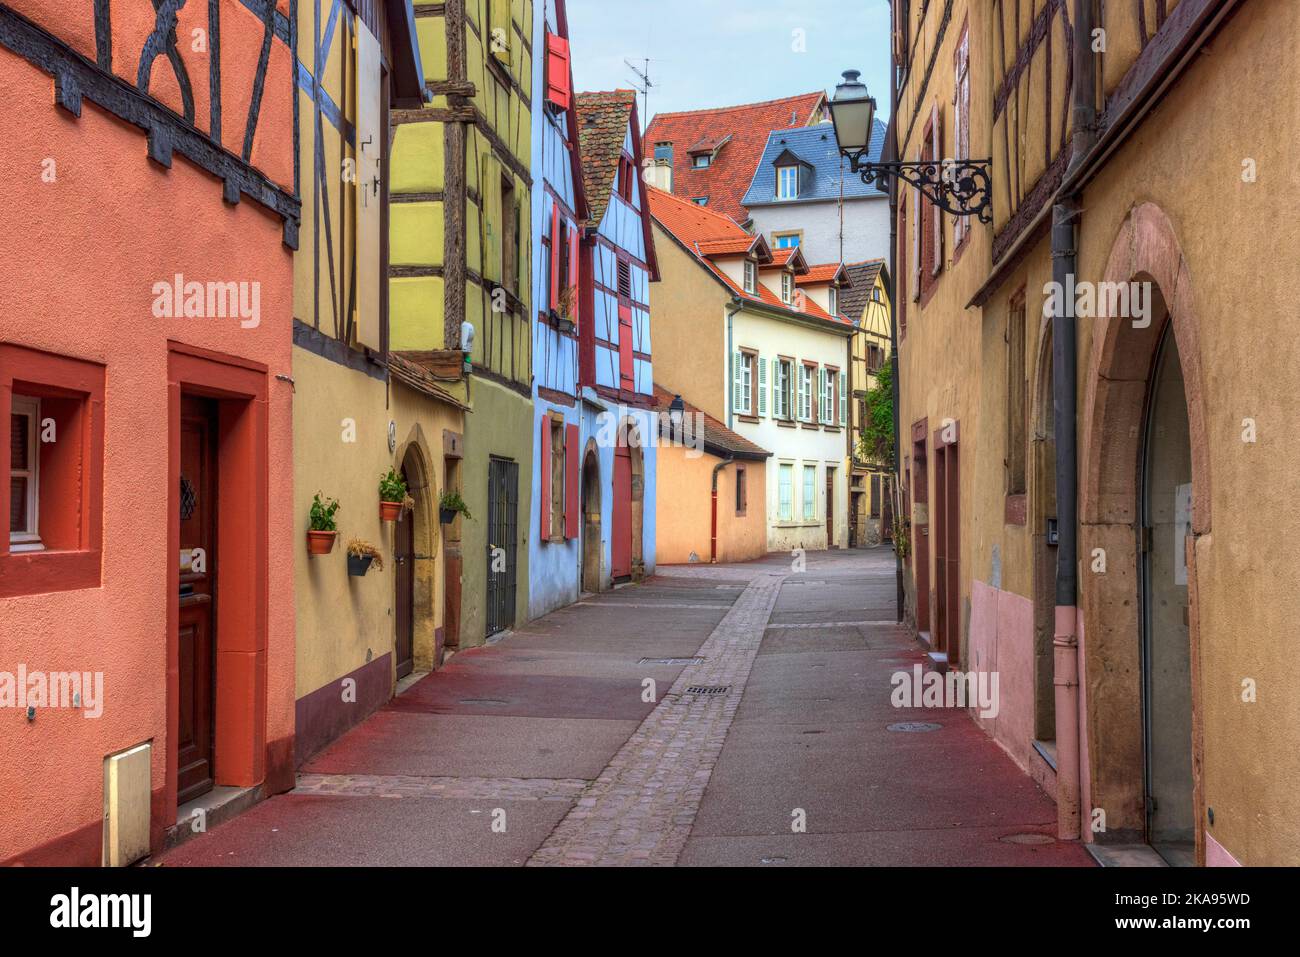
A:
389 0 534 648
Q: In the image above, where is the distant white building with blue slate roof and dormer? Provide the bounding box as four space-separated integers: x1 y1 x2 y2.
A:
741 120 889 269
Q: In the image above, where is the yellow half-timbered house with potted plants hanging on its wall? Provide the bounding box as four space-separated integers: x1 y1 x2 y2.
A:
294 0 465 765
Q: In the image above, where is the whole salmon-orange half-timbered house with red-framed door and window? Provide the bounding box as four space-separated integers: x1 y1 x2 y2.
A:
0 0 300 865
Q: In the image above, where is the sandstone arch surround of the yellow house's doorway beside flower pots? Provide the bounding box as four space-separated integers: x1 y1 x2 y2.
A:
394 429 442 674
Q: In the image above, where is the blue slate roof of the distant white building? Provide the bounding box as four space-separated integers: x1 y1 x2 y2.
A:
741 120 888 207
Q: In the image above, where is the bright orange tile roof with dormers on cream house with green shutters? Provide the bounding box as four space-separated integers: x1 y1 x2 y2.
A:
646 186 852 325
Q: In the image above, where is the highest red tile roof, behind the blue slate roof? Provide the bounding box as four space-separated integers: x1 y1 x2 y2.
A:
645 92 826 222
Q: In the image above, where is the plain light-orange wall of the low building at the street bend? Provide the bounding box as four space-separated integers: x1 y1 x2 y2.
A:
655 445 767 564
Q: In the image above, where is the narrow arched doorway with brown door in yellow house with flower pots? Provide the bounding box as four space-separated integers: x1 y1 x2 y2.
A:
393 441 442 679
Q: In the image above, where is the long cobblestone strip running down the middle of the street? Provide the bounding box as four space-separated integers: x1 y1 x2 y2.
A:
528 572 784 866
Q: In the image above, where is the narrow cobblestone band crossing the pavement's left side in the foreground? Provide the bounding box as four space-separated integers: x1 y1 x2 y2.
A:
293 774 588 802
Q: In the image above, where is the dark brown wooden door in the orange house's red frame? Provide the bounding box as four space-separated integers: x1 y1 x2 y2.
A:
177 397 217 804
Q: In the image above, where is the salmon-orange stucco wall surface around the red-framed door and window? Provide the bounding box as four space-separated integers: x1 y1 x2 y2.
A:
0 29 298 863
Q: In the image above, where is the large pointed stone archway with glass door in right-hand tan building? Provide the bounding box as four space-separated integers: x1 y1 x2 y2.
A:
1079 204 1210 862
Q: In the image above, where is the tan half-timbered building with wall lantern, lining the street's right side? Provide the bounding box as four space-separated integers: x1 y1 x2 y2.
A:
892 0 1300 865
